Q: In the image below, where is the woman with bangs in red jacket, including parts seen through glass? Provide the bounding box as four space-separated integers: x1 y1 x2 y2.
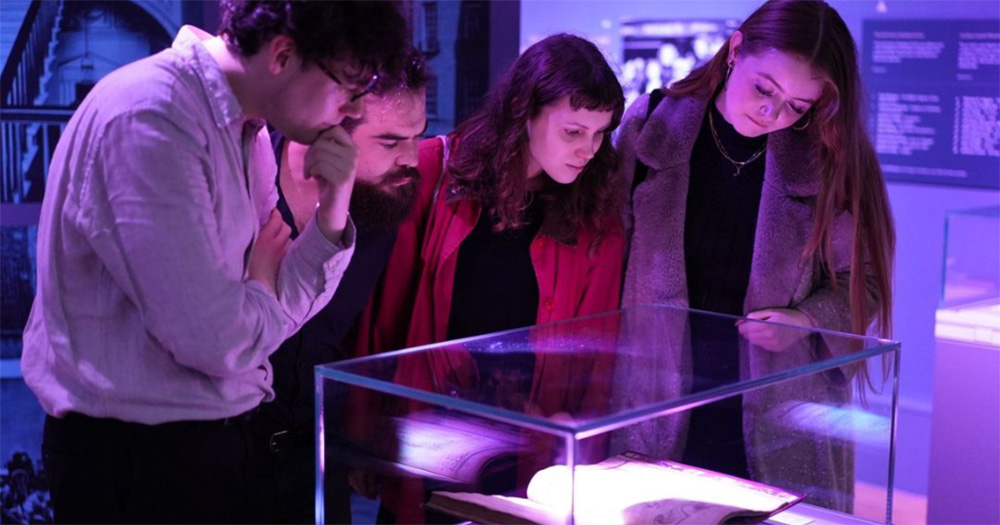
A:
359 34 624 523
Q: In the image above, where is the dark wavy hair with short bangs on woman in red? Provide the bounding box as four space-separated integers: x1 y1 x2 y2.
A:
448 34 625 244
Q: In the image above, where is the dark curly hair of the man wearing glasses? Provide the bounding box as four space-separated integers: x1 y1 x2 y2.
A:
219 0 410 82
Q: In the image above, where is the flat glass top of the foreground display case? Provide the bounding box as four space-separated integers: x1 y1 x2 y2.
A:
317 306 896 435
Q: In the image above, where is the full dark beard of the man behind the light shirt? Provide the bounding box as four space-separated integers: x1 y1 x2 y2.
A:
351 168 420 231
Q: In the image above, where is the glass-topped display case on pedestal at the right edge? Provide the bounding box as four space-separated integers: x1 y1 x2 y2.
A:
927 206 1000 523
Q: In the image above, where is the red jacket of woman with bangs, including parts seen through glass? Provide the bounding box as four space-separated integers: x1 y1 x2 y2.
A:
355 138 624 523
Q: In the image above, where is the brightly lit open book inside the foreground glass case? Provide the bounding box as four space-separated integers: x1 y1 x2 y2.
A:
427 452 803 525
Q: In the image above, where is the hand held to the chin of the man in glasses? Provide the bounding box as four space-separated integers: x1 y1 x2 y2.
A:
304 126 358 243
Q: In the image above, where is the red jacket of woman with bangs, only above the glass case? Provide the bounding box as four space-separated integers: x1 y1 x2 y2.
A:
358 138 624 355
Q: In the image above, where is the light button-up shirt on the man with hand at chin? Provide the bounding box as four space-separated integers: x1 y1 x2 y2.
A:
21 27 354 424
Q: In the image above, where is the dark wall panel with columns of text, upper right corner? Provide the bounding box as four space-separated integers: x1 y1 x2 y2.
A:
862 20 1000 188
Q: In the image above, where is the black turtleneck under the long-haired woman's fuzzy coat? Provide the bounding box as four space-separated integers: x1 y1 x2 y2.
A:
684 99 767 478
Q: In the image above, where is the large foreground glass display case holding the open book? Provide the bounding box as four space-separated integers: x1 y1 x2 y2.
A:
316 306 900 524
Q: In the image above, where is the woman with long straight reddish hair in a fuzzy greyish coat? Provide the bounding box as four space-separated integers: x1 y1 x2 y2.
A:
617 0 895 509
